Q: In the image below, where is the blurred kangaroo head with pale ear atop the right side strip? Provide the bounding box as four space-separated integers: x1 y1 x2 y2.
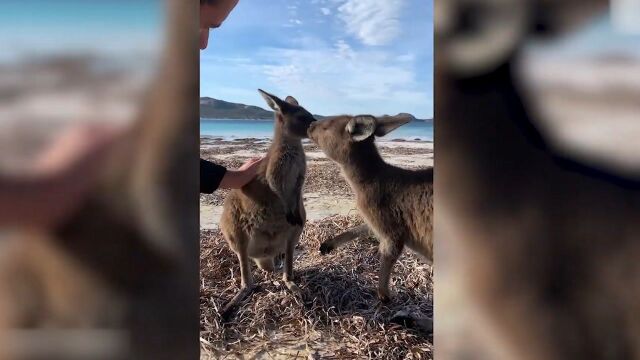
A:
434 0 608 78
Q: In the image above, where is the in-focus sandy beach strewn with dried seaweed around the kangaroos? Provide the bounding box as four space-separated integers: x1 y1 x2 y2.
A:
200 137 433 359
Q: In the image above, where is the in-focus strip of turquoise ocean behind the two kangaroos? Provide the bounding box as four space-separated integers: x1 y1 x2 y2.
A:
200 119 433 141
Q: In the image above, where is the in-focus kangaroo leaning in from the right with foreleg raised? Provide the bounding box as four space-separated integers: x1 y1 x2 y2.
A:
308 114 433 302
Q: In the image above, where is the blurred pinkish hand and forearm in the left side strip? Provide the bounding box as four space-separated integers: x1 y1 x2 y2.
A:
0 124 129 228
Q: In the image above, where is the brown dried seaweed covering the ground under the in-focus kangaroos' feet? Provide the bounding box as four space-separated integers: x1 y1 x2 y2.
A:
200 215 433 359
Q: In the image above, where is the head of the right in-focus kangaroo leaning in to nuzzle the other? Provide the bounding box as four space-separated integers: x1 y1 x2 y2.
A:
308 114 414 164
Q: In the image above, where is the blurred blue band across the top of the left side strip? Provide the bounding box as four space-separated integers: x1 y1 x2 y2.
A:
0 0 164 60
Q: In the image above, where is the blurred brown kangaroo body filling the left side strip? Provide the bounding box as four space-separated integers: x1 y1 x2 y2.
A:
0 0 199 359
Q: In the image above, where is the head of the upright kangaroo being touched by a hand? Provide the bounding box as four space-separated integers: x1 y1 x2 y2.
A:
258 89 316 139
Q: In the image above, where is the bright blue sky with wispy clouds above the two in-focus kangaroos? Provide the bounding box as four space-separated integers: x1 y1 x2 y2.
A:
200 0 433 118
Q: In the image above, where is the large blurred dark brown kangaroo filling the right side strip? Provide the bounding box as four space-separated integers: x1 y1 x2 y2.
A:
435 0 640 359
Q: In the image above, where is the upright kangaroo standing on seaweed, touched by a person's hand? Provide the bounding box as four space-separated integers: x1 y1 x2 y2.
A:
220 90 315 319
